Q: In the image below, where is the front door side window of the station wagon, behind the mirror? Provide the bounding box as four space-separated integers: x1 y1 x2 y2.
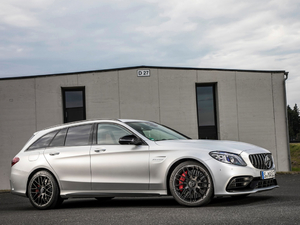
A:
97 124 132 145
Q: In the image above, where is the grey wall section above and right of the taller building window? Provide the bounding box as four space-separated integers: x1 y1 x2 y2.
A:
193 70 290 171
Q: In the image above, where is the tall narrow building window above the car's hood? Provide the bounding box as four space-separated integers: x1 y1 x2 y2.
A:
196 84 218 139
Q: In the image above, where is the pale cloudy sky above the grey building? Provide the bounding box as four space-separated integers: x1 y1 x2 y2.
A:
0 0 300 106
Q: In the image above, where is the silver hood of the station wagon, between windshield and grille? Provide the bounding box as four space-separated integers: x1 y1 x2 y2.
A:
156 139 262 154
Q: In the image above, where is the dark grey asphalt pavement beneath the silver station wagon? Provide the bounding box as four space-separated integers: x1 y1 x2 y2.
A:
0 174 300 225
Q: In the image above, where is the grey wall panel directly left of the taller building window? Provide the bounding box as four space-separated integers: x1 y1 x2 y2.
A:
159 69 198 138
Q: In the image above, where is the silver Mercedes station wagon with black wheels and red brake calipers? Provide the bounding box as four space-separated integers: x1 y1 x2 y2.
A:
10 119 278 209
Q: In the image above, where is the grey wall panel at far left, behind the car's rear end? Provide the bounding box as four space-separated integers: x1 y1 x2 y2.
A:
0 79 36 190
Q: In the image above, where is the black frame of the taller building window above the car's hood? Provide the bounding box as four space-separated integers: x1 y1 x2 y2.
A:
195 82 219 140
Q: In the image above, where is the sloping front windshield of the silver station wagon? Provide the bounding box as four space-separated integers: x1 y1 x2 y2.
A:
126 122 189 141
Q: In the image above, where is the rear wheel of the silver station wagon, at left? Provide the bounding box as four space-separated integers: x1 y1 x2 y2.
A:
27 170 64 209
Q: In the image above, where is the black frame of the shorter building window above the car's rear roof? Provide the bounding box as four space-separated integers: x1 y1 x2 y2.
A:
61 86 86 123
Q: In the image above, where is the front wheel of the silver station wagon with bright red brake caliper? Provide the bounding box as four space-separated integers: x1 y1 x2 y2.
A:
169 161 213 207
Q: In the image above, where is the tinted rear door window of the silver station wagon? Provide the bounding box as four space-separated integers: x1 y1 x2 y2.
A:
65 124 92 146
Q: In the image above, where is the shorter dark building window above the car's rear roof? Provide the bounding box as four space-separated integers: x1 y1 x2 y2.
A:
62 87 86 123
